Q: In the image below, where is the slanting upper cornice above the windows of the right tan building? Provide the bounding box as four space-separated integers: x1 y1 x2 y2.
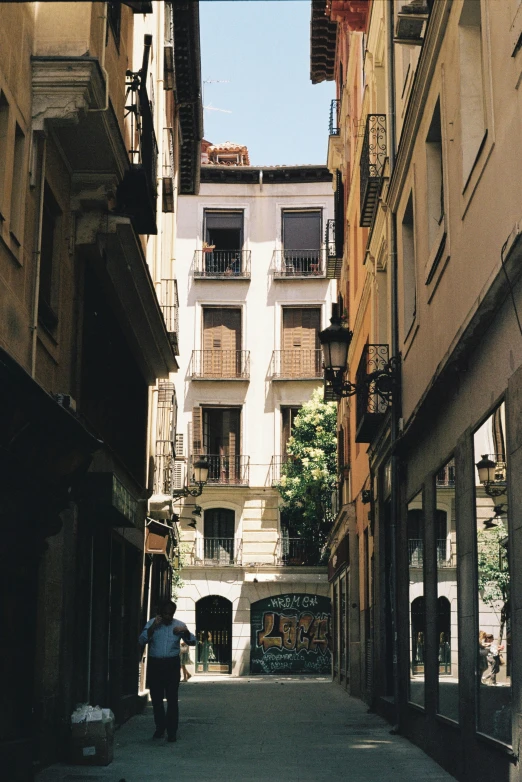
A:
388 0 453 212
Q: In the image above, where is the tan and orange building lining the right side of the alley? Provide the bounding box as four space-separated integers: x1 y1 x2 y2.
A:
311 0 522 780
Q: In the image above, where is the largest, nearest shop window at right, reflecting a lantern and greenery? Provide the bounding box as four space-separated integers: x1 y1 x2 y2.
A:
474 404 512 744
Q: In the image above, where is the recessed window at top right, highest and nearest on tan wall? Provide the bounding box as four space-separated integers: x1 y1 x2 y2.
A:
459 0 486 184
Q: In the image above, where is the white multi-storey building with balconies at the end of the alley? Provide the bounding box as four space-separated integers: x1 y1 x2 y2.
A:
169 142 335 676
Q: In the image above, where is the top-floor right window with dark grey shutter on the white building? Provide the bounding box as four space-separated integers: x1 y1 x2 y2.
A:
283 209 322 274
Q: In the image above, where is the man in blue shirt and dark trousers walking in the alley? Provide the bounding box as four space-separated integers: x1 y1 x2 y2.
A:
138 600 196 741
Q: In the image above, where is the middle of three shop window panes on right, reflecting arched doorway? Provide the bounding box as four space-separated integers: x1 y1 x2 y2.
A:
435 459 459 721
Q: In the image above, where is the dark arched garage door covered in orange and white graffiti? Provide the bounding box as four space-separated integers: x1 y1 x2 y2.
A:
250 593 331 674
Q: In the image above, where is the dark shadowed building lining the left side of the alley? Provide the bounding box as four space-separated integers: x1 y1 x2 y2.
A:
0 2 201 782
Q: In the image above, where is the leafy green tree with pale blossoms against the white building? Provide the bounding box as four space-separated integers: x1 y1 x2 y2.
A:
276 388 337 564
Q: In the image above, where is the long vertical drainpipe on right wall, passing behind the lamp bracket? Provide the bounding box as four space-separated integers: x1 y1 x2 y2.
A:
385 0 400 731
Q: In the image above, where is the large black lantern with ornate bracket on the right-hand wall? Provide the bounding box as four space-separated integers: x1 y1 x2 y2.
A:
319 305 400 403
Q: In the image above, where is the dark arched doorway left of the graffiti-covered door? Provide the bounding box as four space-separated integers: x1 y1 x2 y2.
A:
196 595 232 673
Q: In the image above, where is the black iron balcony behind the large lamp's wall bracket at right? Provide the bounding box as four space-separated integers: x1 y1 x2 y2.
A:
355 345 389 443
